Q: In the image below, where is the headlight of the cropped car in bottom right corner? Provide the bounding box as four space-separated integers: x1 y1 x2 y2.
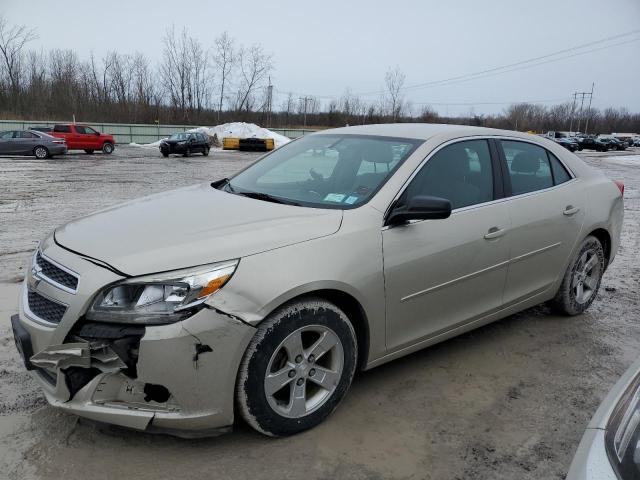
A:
605 375 640 479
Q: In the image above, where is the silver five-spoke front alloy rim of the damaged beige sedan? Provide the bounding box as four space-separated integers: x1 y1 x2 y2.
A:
264 325 344 418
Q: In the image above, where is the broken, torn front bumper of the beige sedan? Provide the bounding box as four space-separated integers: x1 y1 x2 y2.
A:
12 239 255 436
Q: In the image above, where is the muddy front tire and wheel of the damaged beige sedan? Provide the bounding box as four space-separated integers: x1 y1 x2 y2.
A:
236 298 358 437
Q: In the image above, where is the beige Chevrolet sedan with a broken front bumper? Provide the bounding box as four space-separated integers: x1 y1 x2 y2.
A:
12 124 623 436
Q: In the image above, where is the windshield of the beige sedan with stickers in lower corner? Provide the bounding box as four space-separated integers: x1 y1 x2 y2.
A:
225 134 422 209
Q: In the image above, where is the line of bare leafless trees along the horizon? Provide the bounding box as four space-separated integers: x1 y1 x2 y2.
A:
0 16 640 133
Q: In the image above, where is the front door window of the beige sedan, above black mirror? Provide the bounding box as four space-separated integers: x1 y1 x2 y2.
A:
400 140 494 209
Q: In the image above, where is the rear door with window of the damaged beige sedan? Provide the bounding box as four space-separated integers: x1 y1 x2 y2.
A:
499 140 585 306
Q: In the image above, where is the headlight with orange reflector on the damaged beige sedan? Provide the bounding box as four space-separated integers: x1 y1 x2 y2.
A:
86 260 238 325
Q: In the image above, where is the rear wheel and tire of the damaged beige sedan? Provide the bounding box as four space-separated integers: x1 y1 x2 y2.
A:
550 235 605 315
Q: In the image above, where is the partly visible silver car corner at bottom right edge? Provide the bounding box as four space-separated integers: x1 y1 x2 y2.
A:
566 354 640 480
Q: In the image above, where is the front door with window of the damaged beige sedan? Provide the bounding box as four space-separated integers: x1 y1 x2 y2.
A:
382 140 510 352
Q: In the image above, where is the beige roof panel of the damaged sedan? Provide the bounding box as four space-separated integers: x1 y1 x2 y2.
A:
318 123 532 140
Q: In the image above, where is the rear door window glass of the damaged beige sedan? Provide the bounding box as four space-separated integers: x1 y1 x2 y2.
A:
500 140 553 195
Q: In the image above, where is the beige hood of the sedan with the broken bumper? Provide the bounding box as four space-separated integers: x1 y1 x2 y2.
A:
55 184 342 275
